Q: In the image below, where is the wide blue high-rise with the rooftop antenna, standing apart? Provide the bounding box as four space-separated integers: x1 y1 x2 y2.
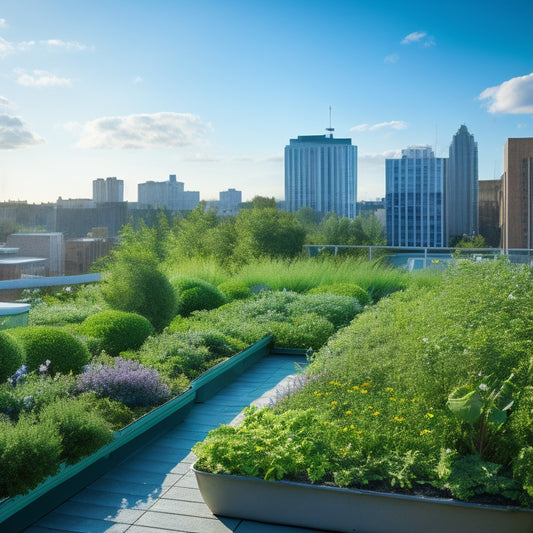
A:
285 134 357 218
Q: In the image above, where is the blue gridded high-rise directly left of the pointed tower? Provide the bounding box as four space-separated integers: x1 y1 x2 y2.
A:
385 146 448 247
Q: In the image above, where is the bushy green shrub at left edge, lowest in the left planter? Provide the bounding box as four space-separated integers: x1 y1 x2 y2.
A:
0 418 61 498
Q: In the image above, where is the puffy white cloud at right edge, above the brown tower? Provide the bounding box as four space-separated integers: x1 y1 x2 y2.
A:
478 72 533 115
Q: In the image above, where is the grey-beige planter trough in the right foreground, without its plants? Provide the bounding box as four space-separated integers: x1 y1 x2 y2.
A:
193 467 533 533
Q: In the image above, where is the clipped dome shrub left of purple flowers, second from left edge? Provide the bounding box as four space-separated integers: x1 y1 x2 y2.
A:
9 326 89 375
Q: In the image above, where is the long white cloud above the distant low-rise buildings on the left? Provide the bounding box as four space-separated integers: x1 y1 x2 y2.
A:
78 112 208 150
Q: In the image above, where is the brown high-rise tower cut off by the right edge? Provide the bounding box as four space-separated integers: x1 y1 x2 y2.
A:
500 137 533 250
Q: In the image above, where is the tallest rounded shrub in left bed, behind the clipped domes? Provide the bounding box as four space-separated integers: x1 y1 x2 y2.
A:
102 257 177 332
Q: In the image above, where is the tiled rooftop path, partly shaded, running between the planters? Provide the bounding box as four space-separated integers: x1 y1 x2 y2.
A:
25 355 316 533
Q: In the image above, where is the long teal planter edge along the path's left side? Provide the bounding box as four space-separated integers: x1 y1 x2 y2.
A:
0 336 272 531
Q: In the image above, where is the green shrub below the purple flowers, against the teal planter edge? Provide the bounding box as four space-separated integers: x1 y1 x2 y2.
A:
39 398 113 464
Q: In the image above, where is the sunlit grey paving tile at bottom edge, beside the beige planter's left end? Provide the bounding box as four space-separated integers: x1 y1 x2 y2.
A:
135 511 239 533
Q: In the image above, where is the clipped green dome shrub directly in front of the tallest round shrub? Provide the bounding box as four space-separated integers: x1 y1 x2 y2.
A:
79 310 154 356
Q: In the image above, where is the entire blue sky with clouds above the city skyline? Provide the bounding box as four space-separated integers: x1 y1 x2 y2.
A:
0 0 533 202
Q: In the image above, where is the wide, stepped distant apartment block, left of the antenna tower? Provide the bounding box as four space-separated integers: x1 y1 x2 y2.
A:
137 174 200 211
